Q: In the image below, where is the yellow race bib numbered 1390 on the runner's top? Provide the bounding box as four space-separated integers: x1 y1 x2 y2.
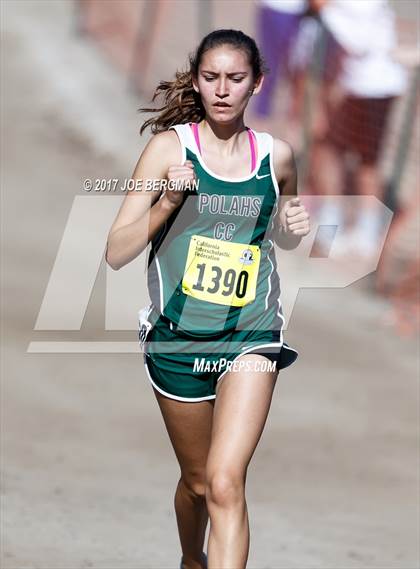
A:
182 235 261 306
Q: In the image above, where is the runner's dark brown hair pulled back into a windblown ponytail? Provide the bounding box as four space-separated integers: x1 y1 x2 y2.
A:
138 30 268 134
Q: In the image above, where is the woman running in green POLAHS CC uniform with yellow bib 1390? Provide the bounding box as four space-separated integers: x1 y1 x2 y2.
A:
106 30 309 569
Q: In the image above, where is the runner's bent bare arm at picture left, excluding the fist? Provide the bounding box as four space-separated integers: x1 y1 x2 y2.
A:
105 131 181 270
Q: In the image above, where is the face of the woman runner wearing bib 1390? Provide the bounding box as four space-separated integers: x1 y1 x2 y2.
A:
193 46 260 123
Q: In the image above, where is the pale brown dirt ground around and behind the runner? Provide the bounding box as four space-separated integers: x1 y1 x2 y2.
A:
1 1 420 569
